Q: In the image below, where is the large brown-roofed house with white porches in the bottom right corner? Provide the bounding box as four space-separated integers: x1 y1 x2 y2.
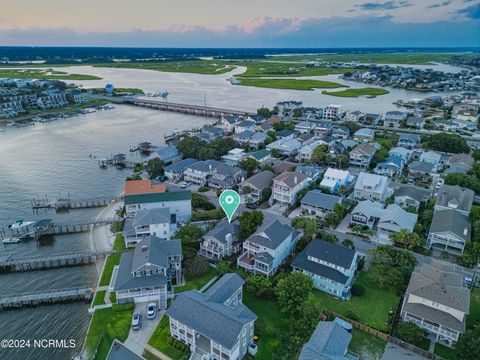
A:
400 260 470 346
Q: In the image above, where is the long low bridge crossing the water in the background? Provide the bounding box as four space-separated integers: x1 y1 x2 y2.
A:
124 98 248 118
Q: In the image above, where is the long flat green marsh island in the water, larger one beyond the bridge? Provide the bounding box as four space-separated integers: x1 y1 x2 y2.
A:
236 78 345 90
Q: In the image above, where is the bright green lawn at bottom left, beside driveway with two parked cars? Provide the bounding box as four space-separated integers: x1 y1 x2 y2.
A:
85 304 135 360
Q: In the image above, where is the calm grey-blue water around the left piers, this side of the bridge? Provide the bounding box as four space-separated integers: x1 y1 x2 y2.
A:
0 106 210 360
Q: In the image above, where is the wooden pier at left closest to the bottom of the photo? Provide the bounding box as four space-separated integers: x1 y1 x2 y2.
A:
0 287 94 310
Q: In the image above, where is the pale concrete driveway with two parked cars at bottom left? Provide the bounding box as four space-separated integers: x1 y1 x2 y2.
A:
125 303 165 355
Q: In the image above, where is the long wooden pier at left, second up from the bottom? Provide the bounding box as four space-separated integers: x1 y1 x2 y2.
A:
0 250 115 272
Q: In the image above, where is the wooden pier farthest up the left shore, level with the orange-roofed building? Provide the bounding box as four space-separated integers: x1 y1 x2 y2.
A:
30 195 117 211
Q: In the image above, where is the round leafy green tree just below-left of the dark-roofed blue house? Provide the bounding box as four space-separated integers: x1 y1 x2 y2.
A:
275 271 313 317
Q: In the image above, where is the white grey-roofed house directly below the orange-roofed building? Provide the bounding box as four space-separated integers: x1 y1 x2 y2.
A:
123 208 177 247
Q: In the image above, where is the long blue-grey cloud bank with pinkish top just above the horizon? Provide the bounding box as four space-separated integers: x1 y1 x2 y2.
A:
0 15 480 48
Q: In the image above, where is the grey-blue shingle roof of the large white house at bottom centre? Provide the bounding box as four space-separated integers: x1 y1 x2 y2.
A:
166 275 257 349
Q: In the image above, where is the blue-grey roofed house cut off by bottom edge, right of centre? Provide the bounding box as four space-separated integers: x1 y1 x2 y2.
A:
298 318 359 360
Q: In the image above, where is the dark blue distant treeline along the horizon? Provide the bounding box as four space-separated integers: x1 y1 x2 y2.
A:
0 46 476 65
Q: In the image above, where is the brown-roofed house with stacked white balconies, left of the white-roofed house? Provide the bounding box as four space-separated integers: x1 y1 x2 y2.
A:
273 172 311 206
